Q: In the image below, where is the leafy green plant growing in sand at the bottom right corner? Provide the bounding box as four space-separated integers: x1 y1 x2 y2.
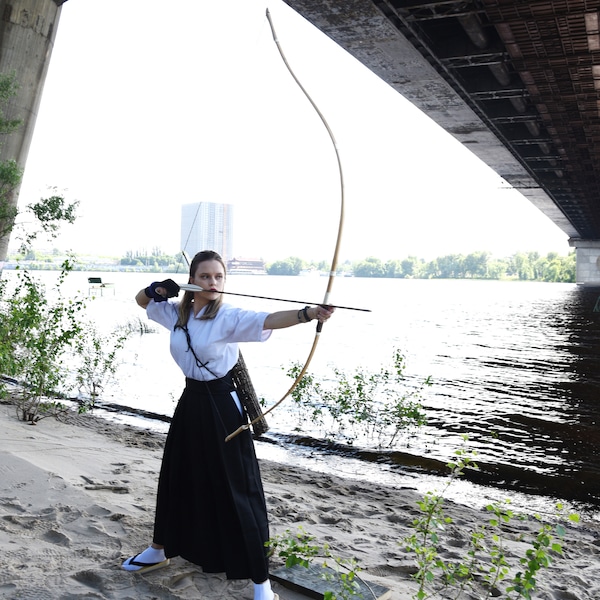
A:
403 436 579 600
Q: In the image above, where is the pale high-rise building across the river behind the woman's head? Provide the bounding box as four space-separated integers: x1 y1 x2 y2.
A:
181 202 233 261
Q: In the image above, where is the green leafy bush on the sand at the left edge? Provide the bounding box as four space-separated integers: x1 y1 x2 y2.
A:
0 260 134 423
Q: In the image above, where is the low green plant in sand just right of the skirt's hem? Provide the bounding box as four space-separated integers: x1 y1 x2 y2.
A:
266 527 370 600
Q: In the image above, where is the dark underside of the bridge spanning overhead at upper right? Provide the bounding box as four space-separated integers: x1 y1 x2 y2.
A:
284 0 600 284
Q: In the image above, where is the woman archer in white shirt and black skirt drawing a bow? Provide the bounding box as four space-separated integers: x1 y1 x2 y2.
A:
122 250 333 600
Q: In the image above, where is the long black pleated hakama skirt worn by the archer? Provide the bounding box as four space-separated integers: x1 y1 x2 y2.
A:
153 376 269 583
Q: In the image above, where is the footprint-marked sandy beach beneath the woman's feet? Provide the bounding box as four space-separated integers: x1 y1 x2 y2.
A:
0 404 600 600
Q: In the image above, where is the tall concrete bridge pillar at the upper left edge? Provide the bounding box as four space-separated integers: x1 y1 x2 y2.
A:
0 0 66 264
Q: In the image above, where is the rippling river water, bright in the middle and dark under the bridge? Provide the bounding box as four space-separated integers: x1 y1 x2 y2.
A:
5 271 600 512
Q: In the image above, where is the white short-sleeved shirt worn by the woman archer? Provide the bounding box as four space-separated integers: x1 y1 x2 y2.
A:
146 300 272 381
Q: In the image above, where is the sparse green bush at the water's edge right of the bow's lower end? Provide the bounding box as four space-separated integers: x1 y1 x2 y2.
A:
287 350 431 448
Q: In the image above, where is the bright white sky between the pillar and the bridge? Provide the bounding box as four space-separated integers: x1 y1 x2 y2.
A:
11 0 570 261
